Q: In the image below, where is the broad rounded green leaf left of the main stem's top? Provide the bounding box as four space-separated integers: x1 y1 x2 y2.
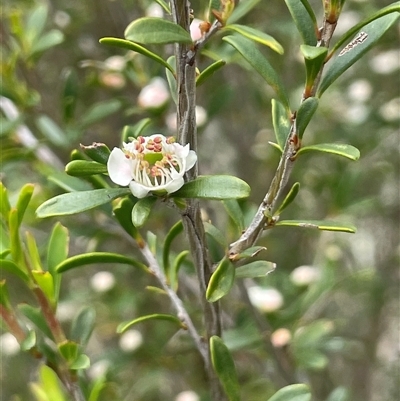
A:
124 17 192 45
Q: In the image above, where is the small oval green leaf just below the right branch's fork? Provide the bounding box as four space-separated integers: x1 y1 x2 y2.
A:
206 258 235 302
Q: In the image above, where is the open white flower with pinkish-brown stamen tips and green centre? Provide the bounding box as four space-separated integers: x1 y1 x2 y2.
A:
107 134 197 198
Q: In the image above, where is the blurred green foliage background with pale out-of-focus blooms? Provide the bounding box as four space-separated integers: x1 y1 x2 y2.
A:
0 0 400 401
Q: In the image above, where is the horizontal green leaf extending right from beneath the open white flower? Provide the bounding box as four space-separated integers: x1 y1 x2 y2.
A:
170 175 250 200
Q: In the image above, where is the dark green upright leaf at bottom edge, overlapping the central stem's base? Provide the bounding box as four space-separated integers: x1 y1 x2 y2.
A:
210 336 240 401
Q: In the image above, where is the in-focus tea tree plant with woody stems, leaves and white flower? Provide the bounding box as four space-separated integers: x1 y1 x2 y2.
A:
0 0 400 401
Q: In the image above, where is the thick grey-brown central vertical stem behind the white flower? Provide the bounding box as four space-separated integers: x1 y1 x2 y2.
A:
171 0 226 401
